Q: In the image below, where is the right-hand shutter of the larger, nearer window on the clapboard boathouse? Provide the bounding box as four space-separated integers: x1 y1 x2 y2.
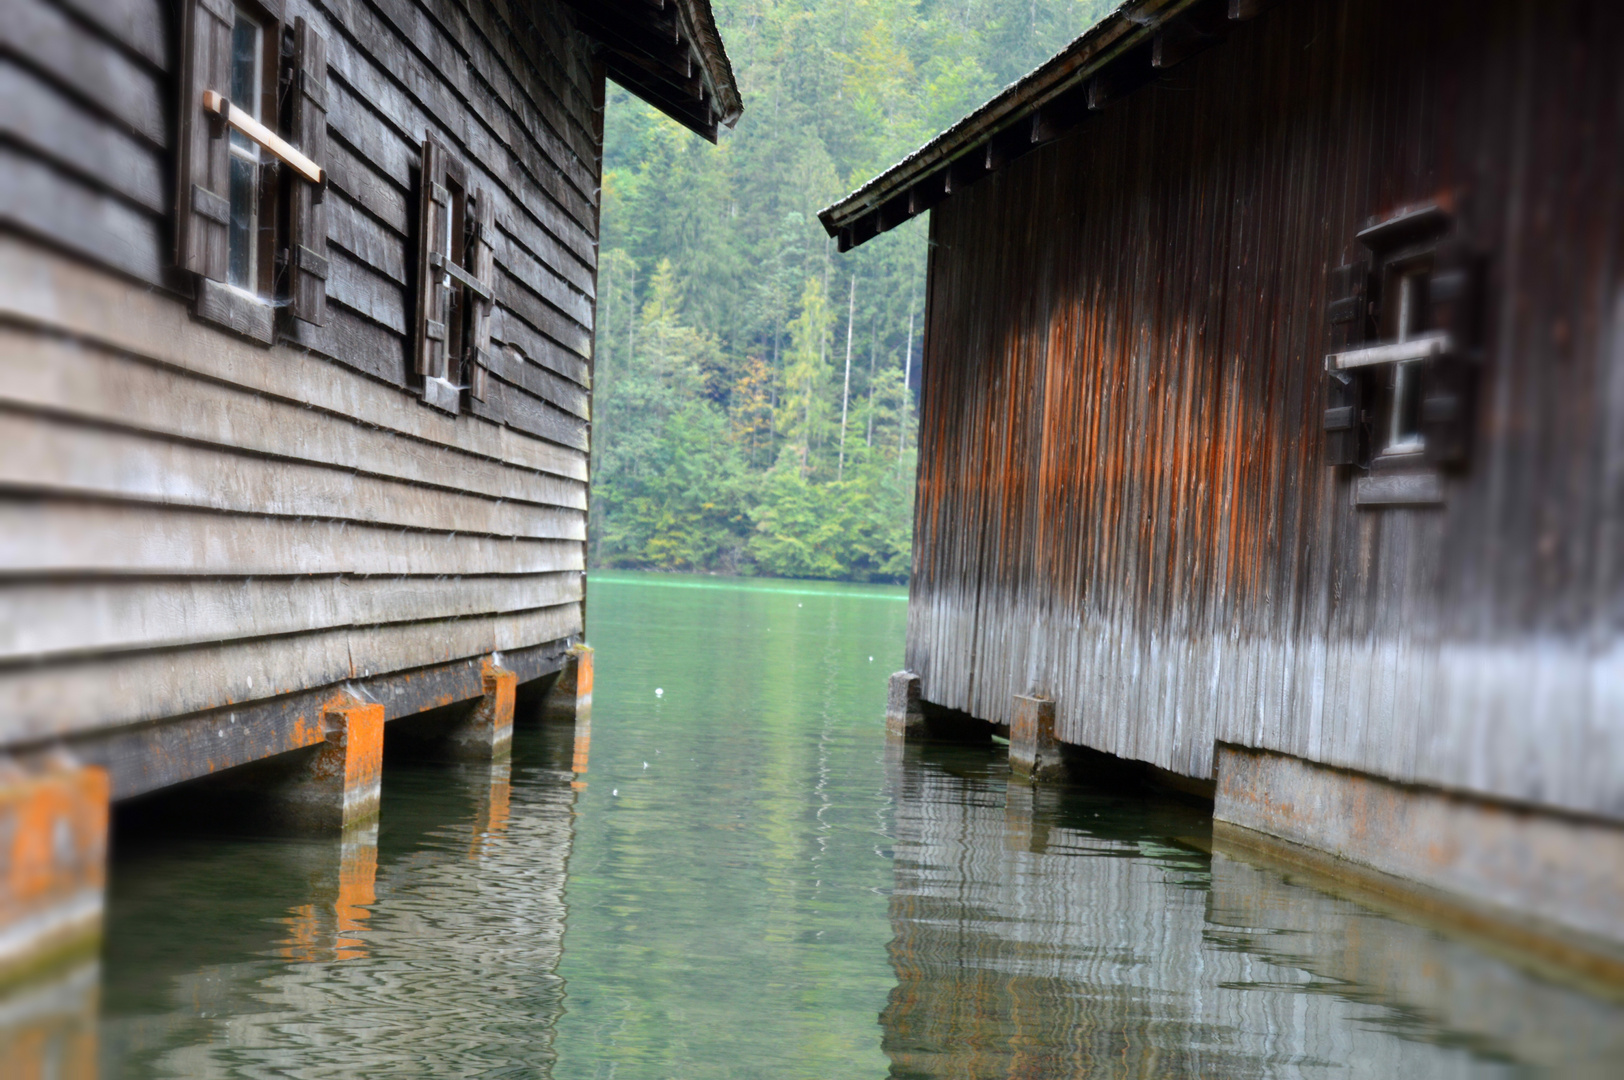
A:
287 16 326 325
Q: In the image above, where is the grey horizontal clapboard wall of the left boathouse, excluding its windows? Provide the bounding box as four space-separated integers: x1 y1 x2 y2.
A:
0 0 603 794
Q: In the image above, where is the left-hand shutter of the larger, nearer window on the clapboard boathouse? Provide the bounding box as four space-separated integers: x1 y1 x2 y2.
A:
175 0 235 281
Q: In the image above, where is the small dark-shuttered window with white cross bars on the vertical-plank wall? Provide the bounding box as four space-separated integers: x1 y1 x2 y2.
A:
1325 205 1478 505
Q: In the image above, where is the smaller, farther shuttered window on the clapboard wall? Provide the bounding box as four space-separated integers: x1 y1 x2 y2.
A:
414 136 495 416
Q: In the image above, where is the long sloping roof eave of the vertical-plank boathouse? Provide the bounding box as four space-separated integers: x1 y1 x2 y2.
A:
818 0 1278 252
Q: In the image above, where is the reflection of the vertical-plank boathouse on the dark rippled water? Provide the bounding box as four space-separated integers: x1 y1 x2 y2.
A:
882 747 1624 1078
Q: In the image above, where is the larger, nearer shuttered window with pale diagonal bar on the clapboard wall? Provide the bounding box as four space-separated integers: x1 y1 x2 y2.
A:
175 0 326 344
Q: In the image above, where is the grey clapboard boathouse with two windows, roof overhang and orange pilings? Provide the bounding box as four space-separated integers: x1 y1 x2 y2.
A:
0 0 741 965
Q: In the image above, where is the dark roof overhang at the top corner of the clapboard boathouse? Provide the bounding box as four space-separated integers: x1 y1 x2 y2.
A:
564 0 744 143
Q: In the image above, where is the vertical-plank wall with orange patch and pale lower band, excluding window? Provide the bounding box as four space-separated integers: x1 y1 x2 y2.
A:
908 0 1624 817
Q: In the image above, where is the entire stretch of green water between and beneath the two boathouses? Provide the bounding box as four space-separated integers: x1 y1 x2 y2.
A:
66 573 1624 1080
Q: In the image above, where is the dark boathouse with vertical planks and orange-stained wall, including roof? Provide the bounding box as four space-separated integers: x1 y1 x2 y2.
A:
822 0 1624 978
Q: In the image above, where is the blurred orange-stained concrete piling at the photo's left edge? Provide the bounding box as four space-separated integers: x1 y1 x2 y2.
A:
0 757 109 981
